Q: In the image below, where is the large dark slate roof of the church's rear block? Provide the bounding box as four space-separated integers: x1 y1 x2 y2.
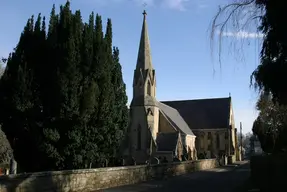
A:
161 97 231 129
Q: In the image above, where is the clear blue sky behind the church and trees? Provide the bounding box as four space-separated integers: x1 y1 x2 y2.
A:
0 0 260 132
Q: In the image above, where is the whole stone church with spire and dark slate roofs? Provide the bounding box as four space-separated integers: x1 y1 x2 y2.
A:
124 11 241 164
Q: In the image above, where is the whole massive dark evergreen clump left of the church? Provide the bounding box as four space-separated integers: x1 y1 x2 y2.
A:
0 1 128 171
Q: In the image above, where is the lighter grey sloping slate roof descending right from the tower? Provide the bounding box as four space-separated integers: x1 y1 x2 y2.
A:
158 102 194 135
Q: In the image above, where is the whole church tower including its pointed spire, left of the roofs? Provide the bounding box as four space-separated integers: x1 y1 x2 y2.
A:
129 11 159 163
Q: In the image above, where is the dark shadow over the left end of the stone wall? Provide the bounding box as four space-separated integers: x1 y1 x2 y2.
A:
0 172 71 192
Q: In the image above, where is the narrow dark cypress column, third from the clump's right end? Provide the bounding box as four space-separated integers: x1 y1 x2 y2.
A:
80 13 99 168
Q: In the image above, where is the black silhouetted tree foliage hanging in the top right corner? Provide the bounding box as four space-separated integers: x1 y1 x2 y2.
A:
252 0 287 105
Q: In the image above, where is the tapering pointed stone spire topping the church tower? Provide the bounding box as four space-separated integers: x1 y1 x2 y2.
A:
136 10 153 70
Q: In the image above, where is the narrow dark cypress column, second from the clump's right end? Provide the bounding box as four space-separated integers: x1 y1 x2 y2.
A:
91 15 112 163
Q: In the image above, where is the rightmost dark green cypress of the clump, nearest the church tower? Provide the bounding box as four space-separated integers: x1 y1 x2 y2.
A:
101 19 127 160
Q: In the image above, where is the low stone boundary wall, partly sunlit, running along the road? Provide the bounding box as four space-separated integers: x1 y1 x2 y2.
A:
0 159 218 192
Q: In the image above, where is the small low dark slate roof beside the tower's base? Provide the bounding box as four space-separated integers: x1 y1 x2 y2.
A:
156 132 179 151
